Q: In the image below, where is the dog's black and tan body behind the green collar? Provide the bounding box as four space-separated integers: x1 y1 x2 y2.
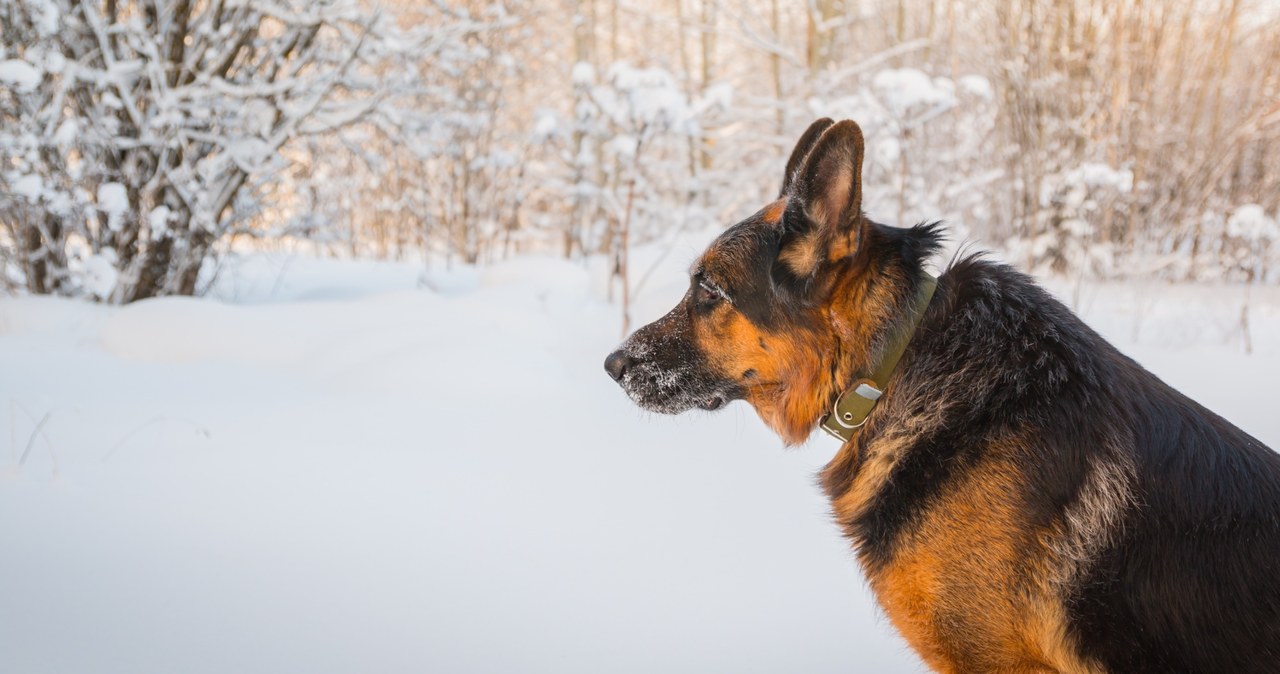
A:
837 256 1280 671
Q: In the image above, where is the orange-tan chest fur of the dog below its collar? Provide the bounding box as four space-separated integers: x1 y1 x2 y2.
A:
833 445 1093 671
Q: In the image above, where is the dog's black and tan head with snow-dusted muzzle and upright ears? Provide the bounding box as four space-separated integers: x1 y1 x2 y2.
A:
604 119 936 443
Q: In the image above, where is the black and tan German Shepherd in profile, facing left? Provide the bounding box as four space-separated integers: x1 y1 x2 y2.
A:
605 119 1280 673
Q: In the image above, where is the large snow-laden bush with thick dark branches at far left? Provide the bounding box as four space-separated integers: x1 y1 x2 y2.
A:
0 0 427 302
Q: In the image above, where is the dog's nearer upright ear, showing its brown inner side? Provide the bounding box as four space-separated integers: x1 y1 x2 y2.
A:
778 119 863 279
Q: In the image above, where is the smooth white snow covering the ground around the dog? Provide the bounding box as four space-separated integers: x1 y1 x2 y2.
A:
0 237 1280 674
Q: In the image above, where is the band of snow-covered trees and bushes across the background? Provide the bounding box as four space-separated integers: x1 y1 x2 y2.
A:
0 0 1280 302
